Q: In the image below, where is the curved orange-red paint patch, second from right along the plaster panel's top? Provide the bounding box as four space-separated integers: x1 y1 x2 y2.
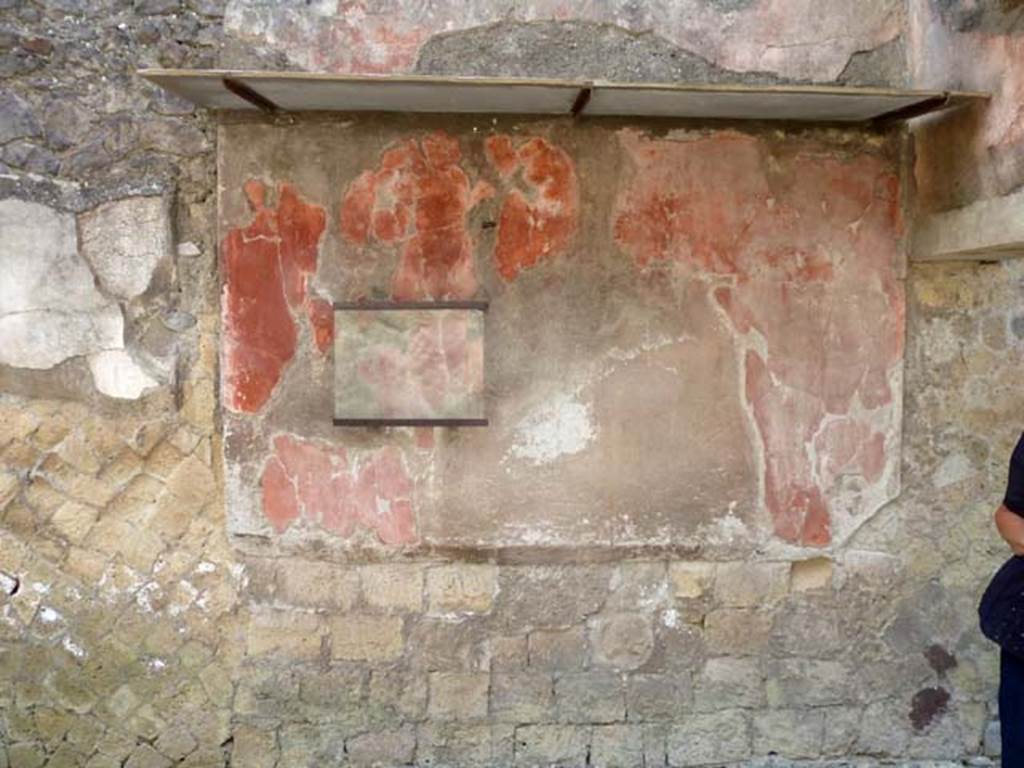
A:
486 134 579 281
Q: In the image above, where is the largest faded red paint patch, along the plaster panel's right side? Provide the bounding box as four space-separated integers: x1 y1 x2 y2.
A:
613 132 904 546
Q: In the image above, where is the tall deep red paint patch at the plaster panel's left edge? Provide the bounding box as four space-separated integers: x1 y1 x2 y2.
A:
223 180 327 413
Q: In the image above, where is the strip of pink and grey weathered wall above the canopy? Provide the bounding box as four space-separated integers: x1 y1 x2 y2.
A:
224 0 905 84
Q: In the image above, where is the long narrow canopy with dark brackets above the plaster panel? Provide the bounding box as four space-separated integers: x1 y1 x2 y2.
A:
139 70 989 123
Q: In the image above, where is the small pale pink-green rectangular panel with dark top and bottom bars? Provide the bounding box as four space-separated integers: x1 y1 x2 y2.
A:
334 301 487 426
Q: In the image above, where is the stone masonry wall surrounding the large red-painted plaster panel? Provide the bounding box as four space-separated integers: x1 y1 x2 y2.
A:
0 0 1024 768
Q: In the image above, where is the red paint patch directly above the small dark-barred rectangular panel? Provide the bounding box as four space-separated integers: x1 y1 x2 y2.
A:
341 131 494 300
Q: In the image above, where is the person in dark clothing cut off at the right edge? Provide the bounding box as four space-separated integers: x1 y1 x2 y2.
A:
995 434 1024 768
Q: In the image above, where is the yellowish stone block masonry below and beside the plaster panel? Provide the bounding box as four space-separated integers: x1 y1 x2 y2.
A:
0 253 1024 768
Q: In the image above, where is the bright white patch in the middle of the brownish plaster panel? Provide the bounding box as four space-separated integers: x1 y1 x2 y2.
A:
508 394 597 464
